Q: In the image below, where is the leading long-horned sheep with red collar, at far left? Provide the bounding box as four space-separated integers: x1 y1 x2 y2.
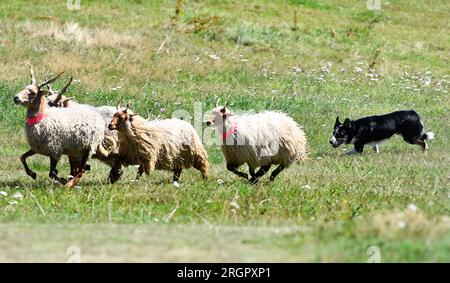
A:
13 64 108 188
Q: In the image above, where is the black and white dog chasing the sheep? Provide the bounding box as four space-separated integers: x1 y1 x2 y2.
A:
330 110 434 154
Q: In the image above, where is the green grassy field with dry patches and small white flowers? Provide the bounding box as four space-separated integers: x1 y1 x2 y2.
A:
0 0 450 262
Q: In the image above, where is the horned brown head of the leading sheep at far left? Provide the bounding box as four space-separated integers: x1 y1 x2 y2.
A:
14 64 64 108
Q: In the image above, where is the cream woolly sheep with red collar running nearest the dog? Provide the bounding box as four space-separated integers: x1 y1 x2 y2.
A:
206 103 307 184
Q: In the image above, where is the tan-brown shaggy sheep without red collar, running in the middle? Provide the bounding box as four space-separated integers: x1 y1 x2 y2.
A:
108 106 209 186
